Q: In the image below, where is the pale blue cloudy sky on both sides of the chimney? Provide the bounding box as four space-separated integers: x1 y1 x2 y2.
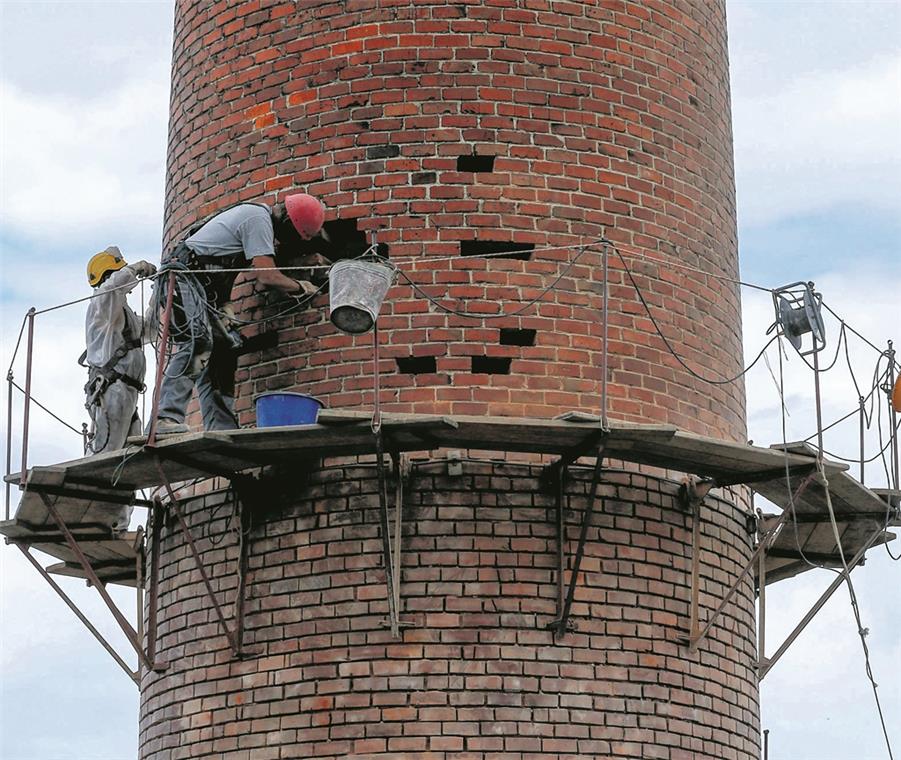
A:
0 0 901 760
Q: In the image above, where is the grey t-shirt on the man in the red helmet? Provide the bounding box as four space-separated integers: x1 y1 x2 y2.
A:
185 203 275 259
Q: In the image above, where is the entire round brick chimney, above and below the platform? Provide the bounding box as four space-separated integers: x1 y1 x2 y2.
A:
156 0 759 760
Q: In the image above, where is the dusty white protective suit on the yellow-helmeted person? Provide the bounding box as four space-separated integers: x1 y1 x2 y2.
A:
85 266 147 454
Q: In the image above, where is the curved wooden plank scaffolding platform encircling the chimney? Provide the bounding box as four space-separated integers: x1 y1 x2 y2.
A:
0 410 899 585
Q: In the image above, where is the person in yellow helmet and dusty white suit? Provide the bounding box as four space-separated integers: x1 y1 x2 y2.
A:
79 246 156 476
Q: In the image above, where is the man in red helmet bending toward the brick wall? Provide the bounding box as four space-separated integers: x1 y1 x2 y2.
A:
148 193 325 434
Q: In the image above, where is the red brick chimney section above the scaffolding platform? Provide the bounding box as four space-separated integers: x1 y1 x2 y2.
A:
166 0 744 440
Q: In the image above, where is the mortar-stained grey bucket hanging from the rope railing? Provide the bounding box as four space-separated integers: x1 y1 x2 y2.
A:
329 256 396 335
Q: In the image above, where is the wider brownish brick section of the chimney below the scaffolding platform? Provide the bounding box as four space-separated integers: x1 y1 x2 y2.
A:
140 460 759 760
